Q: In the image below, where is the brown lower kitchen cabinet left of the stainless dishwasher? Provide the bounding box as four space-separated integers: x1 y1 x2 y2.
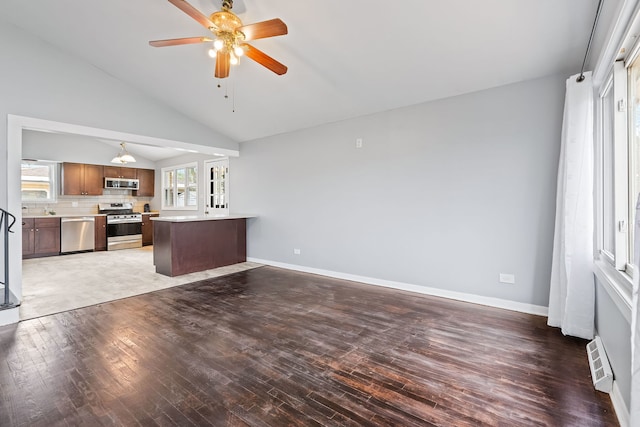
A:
22 218 60 258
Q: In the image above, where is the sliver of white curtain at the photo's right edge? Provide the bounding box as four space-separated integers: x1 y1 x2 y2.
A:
629 195 640 426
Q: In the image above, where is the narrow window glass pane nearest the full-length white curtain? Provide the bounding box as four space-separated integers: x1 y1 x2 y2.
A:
602 85 616 257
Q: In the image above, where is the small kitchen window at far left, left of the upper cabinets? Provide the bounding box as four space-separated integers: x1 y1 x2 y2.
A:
20 160 57 202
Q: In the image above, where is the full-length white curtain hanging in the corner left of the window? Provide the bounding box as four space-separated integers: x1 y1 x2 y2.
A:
547 73 595 339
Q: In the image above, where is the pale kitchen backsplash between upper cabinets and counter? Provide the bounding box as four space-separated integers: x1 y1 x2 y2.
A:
22 190 153 215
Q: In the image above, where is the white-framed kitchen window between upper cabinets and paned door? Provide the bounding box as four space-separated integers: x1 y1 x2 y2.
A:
162 163 198 210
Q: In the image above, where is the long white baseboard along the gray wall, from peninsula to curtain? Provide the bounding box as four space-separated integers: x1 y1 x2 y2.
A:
247 257 549 317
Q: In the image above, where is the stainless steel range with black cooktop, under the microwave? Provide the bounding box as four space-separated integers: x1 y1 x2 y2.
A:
98 203 142 251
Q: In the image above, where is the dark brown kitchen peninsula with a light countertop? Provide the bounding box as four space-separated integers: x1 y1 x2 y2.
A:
151 214 254 277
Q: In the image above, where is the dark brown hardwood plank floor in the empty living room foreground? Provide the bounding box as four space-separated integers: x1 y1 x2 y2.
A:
0 267 617 427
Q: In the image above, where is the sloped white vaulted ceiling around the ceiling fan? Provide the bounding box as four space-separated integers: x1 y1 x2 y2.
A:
0 0 598 142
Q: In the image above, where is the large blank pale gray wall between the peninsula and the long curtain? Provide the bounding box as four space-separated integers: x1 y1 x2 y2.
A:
230 76 565 306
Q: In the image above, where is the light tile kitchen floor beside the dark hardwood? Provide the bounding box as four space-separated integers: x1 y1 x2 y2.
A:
20 246 260 320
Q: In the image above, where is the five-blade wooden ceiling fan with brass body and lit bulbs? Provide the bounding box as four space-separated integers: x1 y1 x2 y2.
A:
149 0 288 79
